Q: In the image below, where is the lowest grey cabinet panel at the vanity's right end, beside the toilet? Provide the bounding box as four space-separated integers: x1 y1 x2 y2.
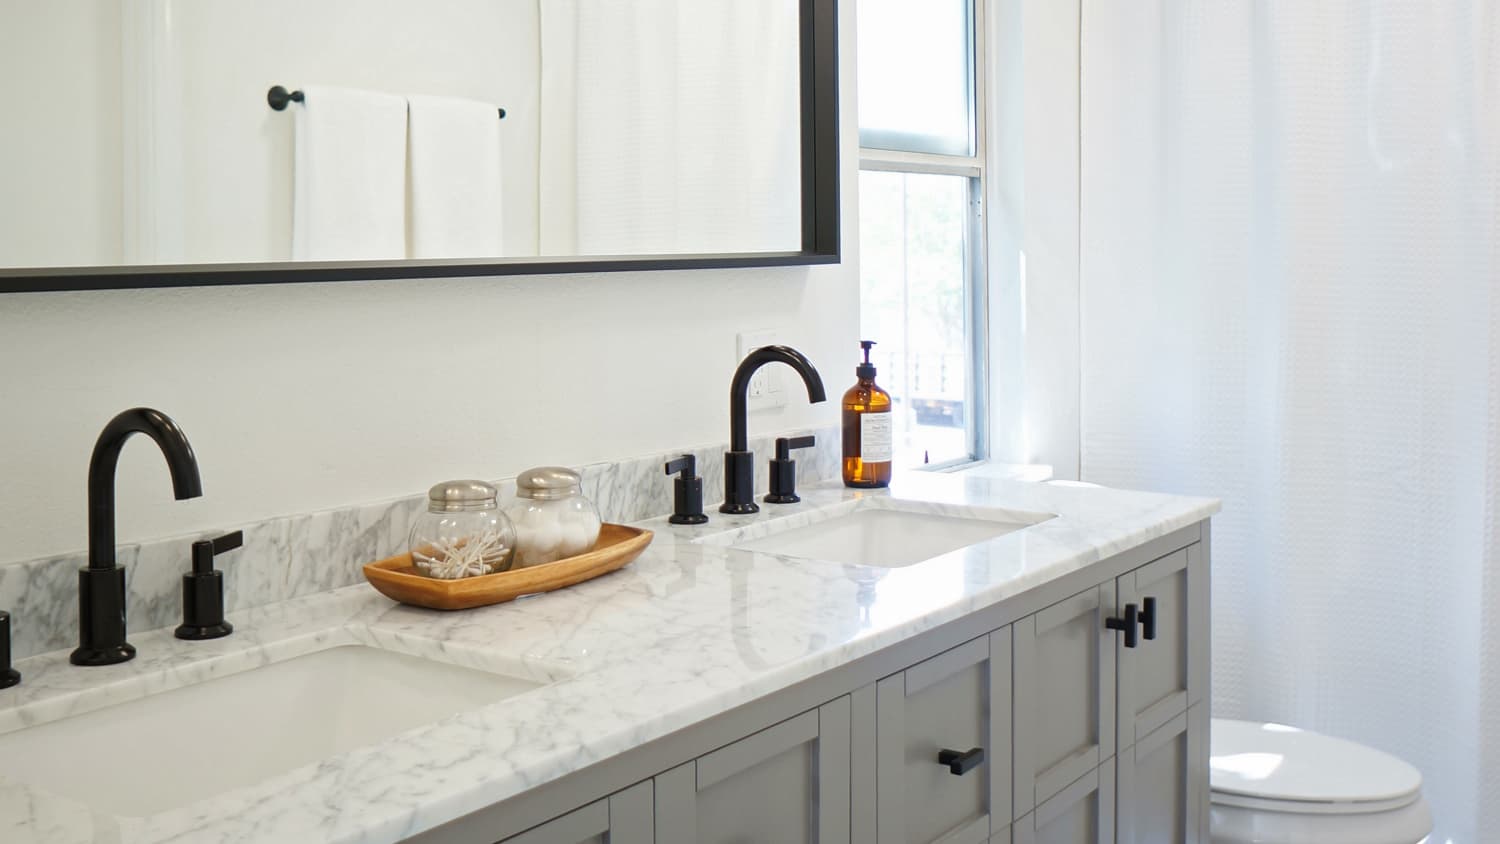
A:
1116 705 1209 844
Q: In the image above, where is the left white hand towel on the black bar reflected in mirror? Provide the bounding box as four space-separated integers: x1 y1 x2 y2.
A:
291 85 407 261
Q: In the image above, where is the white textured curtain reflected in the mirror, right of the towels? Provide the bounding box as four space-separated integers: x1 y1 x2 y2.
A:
542 0 801 255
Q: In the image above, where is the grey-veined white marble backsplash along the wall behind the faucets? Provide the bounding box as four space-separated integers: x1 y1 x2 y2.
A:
0 427 840 660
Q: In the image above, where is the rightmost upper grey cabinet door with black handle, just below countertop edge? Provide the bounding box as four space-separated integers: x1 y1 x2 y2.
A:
1116 544 1209 750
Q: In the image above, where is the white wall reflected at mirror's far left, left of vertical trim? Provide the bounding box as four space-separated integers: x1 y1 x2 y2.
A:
0 0 120 267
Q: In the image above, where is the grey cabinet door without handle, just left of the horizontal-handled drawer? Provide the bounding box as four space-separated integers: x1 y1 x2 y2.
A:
656 697 849 844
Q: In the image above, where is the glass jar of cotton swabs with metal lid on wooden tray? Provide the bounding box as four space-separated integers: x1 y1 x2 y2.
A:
408 481 516 580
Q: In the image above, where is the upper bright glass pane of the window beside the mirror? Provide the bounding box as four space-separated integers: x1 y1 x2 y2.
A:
858 0 974 156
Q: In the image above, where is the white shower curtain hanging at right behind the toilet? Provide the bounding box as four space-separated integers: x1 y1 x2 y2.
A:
1080 0 1500 844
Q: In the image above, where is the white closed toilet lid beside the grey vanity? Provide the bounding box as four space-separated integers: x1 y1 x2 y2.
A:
1209 718 1422 804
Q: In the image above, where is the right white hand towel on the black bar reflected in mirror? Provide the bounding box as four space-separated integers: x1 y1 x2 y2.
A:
408 96 504 258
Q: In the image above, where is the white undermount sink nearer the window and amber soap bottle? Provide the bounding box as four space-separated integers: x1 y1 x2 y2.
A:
701 499 1053 568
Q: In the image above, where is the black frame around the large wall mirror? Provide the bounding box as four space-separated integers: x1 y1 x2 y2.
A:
0 0 840 292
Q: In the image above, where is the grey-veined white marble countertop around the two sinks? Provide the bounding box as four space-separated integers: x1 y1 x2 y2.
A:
0 472 1218 844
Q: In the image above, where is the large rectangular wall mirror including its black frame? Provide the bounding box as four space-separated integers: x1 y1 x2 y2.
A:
0 0 837 292
